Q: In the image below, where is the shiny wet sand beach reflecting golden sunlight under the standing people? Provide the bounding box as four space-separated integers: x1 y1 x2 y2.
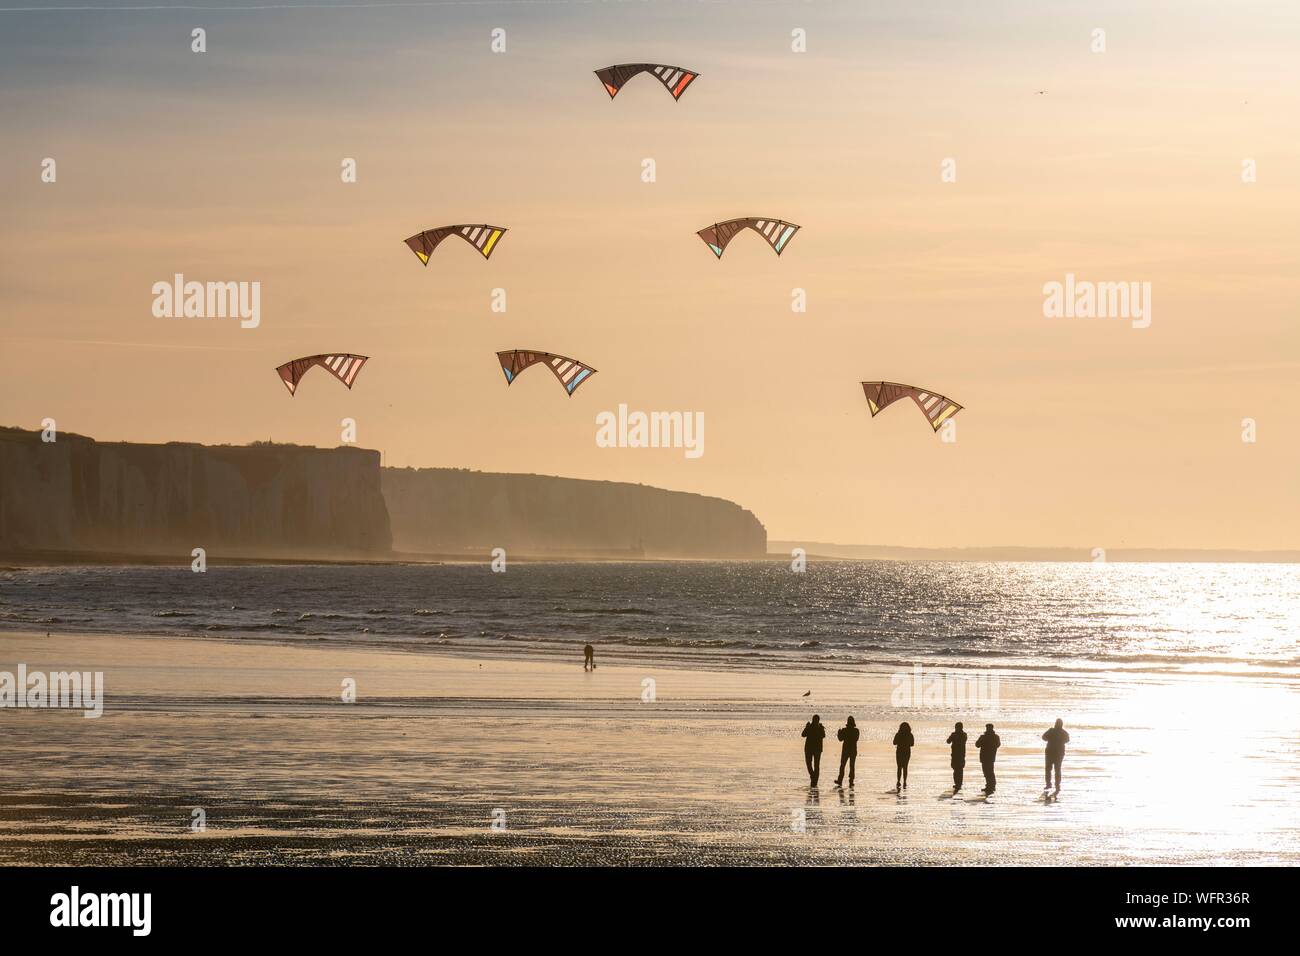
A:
0 633 1300 865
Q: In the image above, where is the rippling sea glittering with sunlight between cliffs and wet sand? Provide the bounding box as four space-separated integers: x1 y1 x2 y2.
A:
0 561 1300 680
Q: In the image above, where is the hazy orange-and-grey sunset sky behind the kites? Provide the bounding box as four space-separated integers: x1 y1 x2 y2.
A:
0 0 1300 549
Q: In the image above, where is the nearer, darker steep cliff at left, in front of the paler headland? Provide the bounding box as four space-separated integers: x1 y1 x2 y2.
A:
0 428 393 561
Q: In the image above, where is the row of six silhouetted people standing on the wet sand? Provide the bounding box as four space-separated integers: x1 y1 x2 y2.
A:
802 714 1070 796
